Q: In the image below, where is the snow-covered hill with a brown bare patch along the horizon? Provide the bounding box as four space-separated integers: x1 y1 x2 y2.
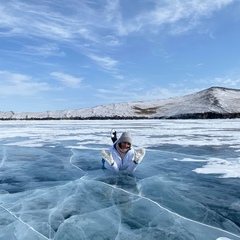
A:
0 87 240 120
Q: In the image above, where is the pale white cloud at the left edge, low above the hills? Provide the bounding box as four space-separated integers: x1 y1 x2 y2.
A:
0 71 50 96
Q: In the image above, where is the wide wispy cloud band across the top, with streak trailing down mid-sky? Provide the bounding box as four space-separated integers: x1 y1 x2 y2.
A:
0 0 237 74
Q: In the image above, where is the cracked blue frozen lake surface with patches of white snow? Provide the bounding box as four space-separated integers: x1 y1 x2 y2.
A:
0 119 240 240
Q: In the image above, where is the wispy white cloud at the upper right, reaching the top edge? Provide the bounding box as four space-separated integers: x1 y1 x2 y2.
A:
130 0 236 34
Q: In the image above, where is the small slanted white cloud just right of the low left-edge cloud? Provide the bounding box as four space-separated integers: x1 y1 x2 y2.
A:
51 72 83 88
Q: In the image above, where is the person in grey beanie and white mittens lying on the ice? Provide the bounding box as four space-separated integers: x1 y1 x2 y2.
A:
101 131 146 173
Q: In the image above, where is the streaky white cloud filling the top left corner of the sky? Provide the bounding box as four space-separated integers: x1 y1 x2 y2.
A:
0 0 93 41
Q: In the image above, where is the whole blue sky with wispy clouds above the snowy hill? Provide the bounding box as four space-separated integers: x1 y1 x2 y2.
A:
0 0 240 112
